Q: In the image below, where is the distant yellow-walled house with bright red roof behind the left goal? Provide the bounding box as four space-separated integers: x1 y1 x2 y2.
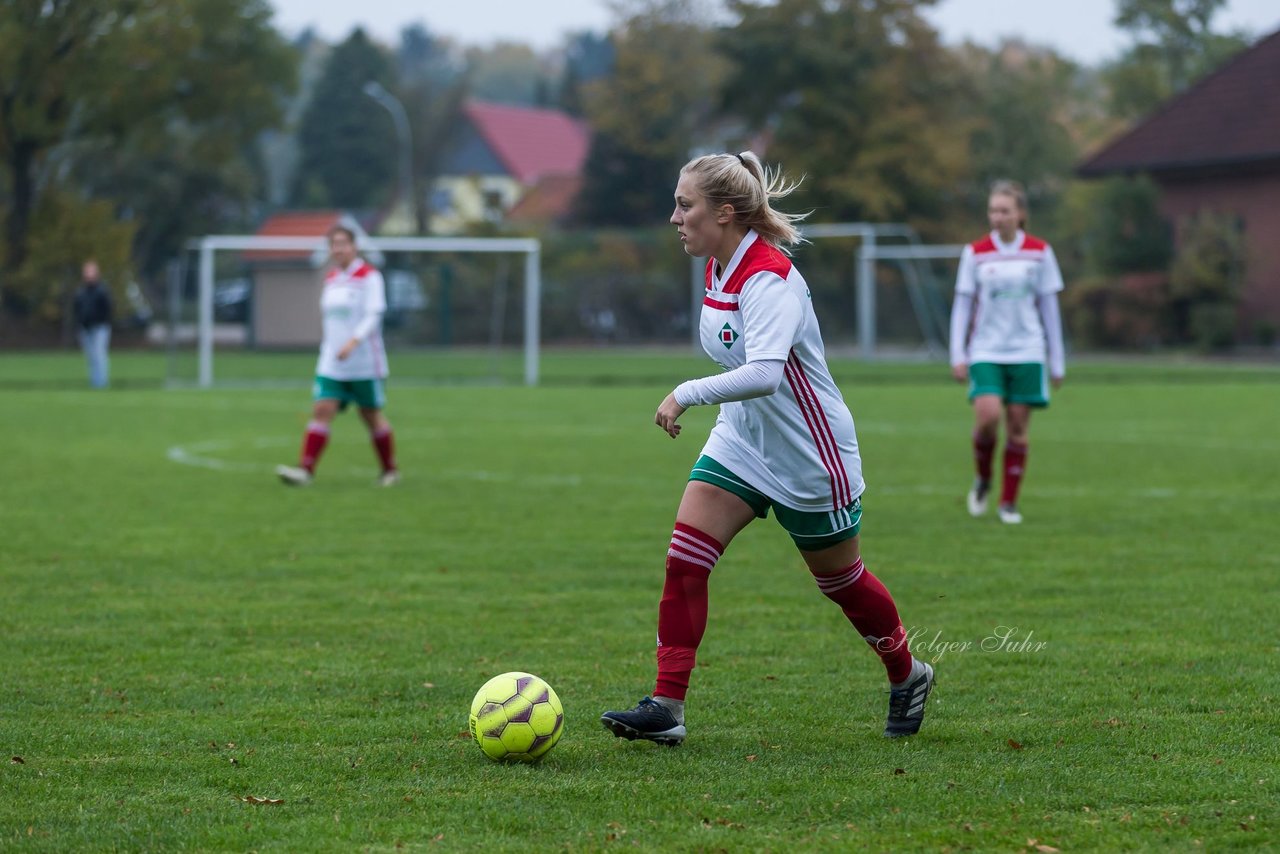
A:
431 101 591 233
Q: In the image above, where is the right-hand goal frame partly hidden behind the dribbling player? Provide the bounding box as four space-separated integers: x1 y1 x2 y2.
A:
690 223 964 360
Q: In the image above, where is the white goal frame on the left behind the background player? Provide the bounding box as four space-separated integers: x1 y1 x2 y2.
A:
188 234 543 388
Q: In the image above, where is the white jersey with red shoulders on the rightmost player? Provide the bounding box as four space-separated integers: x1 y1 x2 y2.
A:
951 230 1062 365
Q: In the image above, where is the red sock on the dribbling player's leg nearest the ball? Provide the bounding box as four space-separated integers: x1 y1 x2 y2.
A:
653 522 724 700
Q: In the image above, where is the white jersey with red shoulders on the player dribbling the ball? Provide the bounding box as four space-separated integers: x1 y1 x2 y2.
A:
700 230 865 512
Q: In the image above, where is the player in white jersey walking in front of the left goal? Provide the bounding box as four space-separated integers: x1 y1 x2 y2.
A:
275 225 399 487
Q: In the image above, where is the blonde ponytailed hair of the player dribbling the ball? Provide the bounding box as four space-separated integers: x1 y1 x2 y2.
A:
680 151 809 252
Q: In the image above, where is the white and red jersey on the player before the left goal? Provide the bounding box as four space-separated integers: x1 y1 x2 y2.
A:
316 257 387 380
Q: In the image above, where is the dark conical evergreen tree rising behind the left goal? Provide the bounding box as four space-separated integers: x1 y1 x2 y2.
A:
293 28 399 209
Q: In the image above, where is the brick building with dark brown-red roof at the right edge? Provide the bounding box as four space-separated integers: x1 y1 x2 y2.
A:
1076 32 1280 338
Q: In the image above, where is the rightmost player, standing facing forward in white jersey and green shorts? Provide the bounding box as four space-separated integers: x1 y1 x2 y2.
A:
951 181 1066 525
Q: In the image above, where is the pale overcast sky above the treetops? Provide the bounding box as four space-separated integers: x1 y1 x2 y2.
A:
269 0 1280 63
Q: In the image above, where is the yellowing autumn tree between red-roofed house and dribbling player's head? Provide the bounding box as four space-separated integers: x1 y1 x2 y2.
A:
575 0 723 225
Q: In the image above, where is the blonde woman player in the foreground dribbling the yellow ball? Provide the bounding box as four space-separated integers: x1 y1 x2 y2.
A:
600 152 933 745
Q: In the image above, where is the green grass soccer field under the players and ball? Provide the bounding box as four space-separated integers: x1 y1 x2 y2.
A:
0 353 1280 851
